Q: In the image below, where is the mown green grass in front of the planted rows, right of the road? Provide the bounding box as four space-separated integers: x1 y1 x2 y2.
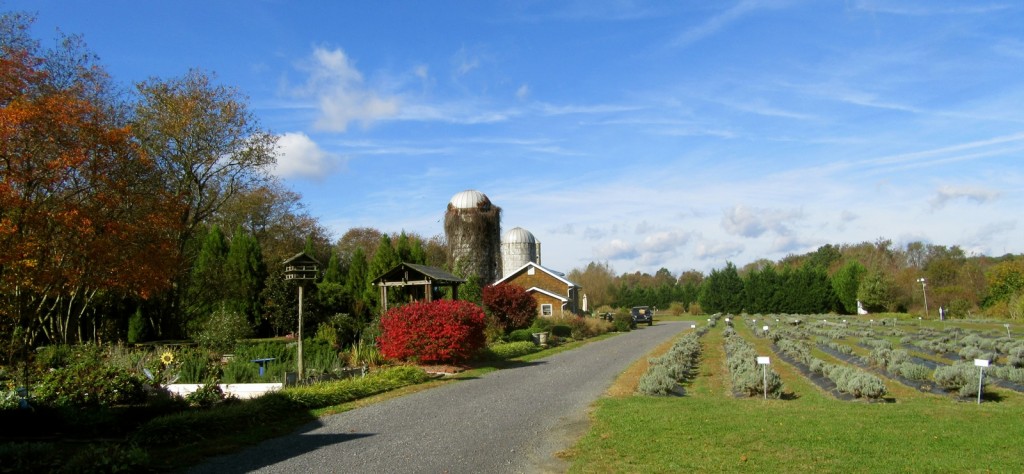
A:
564 325 1024 473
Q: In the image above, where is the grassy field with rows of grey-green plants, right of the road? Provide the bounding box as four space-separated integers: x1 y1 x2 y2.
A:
566 315 1024 472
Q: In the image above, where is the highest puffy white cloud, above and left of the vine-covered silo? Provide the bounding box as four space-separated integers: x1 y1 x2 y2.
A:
298 47 399 132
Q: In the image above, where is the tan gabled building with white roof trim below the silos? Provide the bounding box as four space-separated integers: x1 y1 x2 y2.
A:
495 262 580 317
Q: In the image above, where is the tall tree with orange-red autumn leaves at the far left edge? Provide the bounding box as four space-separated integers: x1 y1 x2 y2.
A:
0 14 179 343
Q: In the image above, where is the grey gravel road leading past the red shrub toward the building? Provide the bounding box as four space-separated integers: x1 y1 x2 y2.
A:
190 321 690 474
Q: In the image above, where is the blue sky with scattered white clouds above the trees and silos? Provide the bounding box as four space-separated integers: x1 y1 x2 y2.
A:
14 0 1024 274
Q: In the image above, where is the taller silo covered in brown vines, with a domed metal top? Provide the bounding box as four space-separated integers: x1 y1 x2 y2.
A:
444 189 502 287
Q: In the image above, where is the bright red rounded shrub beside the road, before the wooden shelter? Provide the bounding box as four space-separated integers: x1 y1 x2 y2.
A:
377 300 486 362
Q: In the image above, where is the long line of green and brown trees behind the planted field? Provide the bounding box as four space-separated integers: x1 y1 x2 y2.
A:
569 239 1024 319
